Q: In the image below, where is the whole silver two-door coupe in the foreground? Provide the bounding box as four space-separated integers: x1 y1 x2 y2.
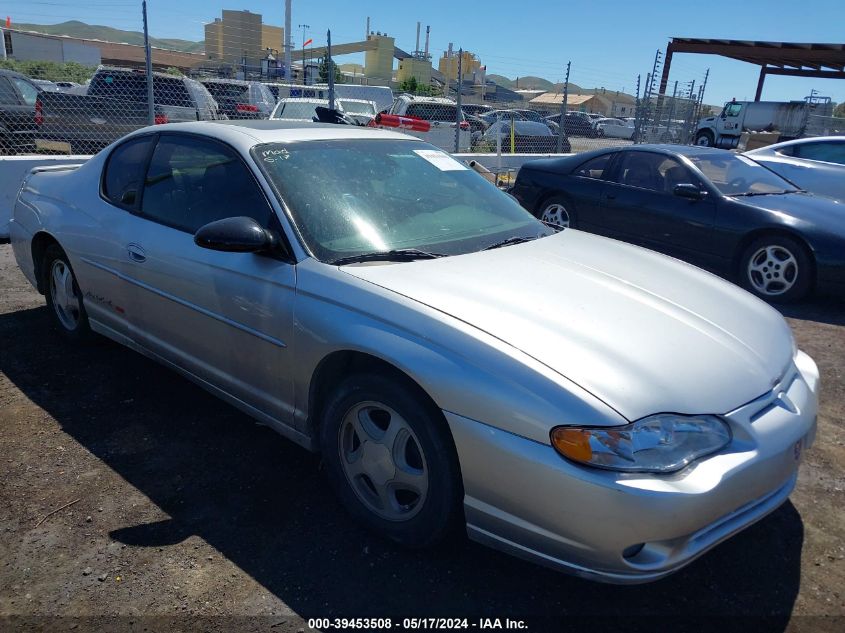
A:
12 121 819 583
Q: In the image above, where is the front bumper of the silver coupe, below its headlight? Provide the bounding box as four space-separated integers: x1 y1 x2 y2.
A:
445 352 818 584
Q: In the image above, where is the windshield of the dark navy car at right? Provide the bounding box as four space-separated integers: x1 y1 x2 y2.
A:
688 152 799 196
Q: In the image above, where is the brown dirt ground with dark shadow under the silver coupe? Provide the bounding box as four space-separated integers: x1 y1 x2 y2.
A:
0 239 845 632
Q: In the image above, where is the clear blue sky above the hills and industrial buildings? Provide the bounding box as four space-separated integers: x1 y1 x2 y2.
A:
6 0 845 104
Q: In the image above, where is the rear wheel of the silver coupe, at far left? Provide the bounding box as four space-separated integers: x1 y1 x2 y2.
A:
40 244 91 341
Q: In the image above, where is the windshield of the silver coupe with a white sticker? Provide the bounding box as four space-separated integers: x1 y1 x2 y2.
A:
252 139 553 262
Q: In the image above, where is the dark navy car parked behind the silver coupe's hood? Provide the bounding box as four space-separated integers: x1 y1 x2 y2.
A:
512 145 845 301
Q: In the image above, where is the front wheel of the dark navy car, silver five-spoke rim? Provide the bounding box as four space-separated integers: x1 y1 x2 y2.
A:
739 235 814 303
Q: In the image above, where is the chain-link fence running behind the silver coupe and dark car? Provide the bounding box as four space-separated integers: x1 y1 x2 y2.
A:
0 57 845 155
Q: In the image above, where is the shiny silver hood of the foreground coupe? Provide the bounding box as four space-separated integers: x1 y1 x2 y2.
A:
342 229 793 420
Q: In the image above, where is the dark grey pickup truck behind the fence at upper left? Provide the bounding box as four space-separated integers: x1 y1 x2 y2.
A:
34 66 223 154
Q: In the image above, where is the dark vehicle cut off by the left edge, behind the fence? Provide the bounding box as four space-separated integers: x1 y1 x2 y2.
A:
0 69 42 154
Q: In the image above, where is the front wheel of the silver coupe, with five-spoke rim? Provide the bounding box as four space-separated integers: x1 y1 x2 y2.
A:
320 374 463 547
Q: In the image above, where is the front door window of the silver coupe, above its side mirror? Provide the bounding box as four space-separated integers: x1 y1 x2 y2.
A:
141 136 272 233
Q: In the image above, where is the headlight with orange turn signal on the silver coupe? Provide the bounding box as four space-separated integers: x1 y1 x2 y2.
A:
551 413 731 473
